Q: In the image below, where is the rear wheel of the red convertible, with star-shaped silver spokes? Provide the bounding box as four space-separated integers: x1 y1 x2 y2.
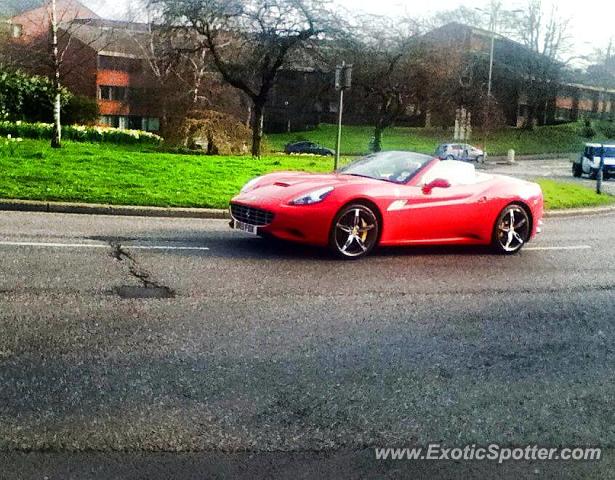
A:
492 204 531 255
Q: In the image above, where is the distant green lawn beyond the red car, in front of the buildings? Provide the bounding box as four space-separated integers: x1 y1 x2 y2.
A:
267 123 608 155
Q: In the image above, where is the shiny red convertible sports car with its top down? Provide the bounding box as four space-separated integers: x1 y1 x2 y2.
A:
230 152 543 258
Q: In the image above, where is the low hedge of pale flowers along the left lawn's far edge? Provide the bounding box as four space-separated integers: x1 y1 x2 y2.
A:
0 121 162 145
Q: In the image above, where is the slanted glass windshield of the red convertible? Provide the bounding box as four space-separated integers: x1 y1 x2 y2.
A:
339 152 433 183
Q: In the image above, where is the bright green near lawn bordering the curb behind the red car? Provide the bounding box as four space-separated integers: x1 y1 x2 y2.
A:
0 140 614 209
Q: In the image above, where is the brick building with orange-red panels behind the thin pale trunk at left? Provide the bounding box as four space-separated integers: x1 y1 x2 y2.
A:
8 0 160 132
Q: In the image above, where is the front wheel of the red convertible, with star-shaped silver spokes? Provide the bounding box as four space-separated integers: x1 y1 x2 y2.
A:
329 203 380 259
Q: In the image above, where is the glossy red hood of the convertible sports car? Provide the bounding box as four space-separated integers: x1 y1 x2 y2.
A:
233 172 382 202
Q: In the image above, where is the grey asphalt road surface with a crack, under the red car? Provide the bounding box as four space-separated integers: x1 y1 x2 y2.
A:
0 212 615 479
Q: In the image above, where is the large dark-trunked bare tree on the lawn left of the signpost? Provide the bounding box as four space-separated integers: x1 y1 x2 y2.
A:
156 0 333 157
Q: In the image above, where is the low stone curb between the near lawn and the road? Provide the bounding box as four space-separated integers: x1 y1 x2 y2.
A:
0 199 615 220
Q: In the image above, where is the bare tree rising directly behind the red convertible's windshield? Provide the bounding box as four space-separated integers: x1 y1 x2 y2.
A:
339 16 453 151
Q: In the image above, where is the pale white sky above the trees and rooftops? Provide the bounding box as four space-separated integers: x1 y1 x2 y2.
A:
88 0 615 63
